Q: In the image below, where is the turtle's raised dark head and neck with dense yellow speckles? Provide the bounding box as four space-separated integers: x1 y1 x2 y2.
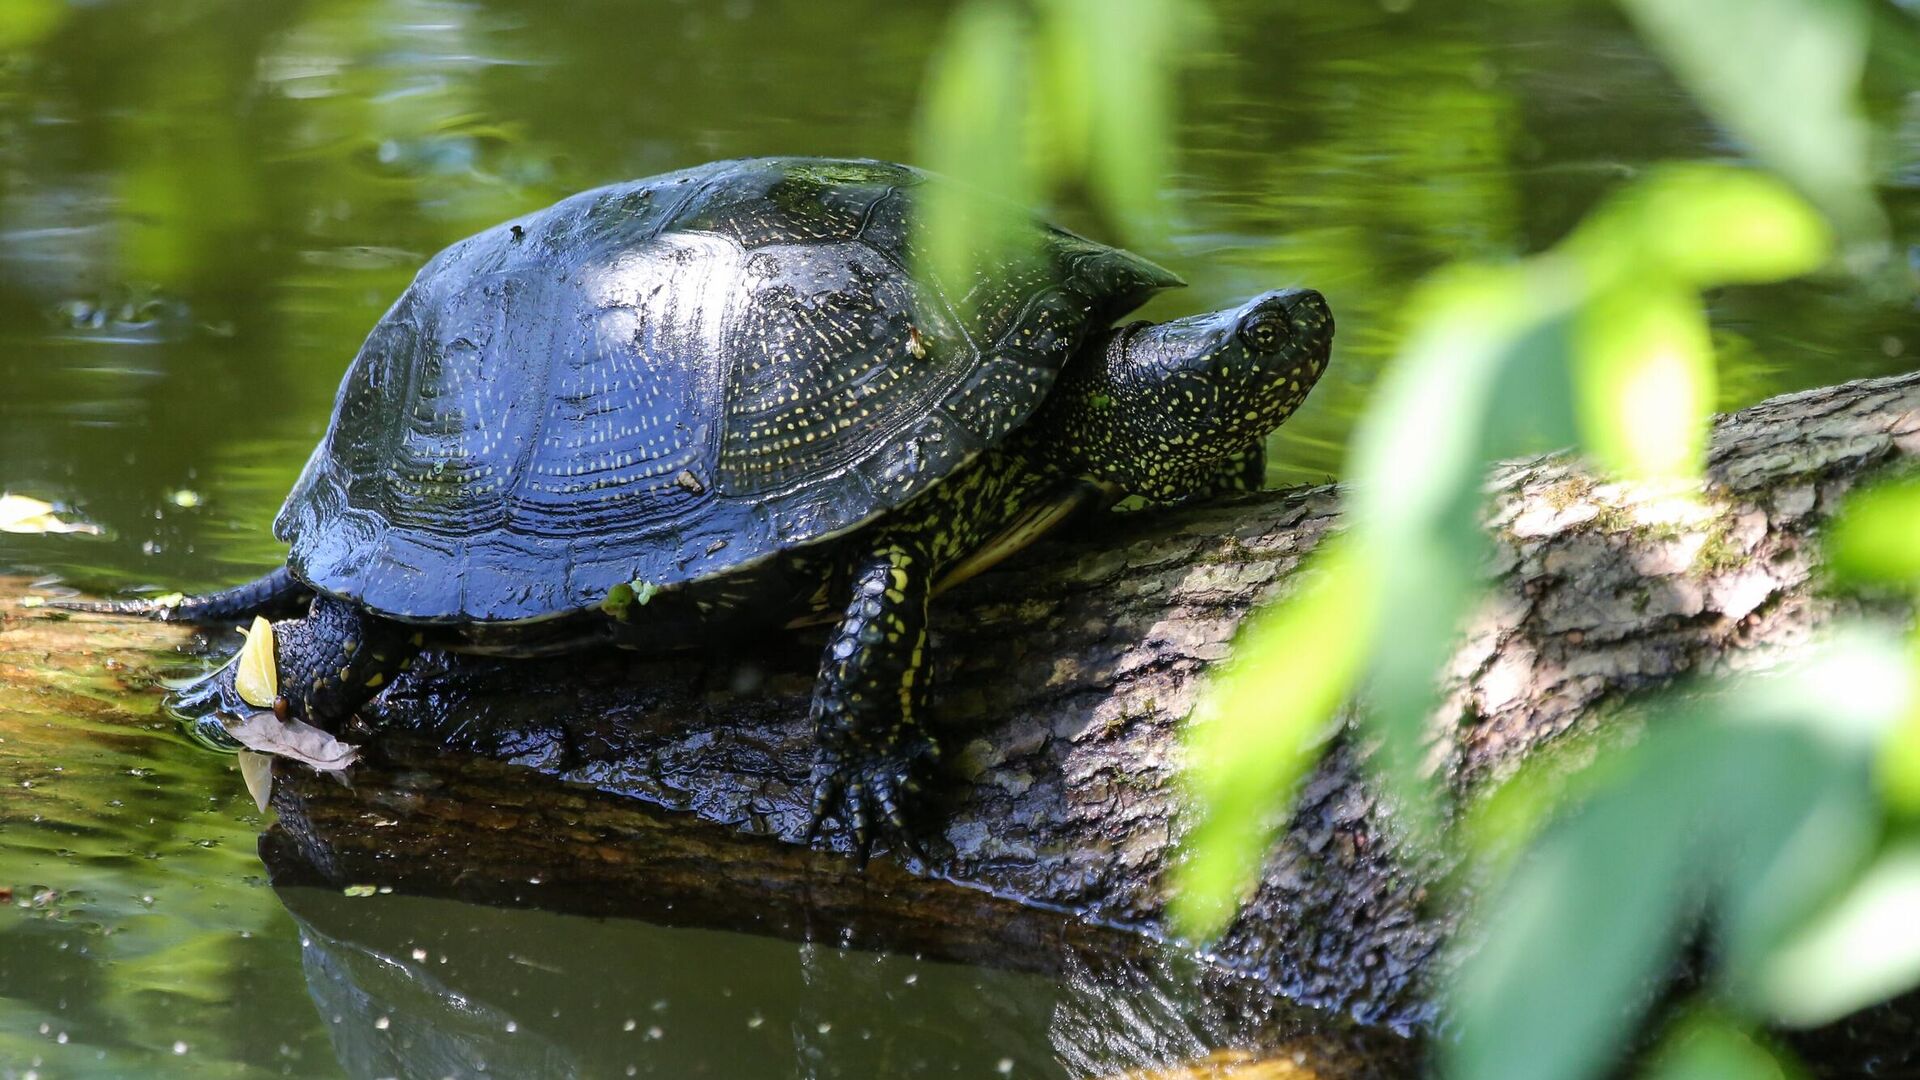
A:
1046 288 1332 500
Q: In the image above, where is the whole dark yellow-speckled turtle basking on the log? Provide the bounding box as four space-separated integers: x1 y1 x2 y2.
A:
86 160 1332 851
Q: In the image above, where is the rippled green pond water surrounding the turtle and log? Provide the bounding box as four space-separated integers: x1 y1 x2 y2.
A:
0 0 1920 1076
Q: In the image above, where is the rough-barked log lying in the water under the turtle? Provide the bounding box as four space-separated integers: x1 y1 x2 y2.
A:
15 367 1920 1030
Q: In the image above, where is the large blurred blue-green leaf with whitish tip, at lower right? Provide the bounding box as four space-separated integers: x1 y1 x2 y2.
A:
1448 634 1910 1080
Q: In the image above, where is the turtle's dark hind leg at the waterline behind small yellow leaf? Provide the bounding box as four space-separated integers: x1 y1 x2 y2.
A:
173 596 420 730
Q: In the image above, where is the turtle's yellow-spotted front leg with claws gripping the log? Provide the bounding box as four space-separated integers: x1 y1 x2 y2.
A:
808 540 939 863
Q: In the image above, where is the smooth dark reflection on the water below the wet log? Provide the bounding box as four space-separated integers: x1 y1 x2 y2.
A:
280 888 1386 1080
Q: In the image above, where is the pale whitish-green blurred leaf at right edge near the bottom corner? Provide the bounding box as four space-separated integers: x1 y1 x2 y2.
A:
1759 840 1920 1026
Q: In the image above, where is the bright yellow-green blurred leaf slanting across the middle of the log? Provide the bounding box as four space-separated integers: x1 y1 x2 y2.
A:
1173 540 1379 938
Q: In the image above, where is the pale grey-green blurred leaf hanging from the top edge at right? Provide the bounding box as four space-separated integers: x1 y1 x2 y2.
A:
1620 0 1880 233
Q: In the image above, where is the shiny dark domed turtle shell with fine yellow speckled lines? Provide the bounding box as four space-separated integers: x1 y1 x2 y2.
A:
275 158 1179 623
